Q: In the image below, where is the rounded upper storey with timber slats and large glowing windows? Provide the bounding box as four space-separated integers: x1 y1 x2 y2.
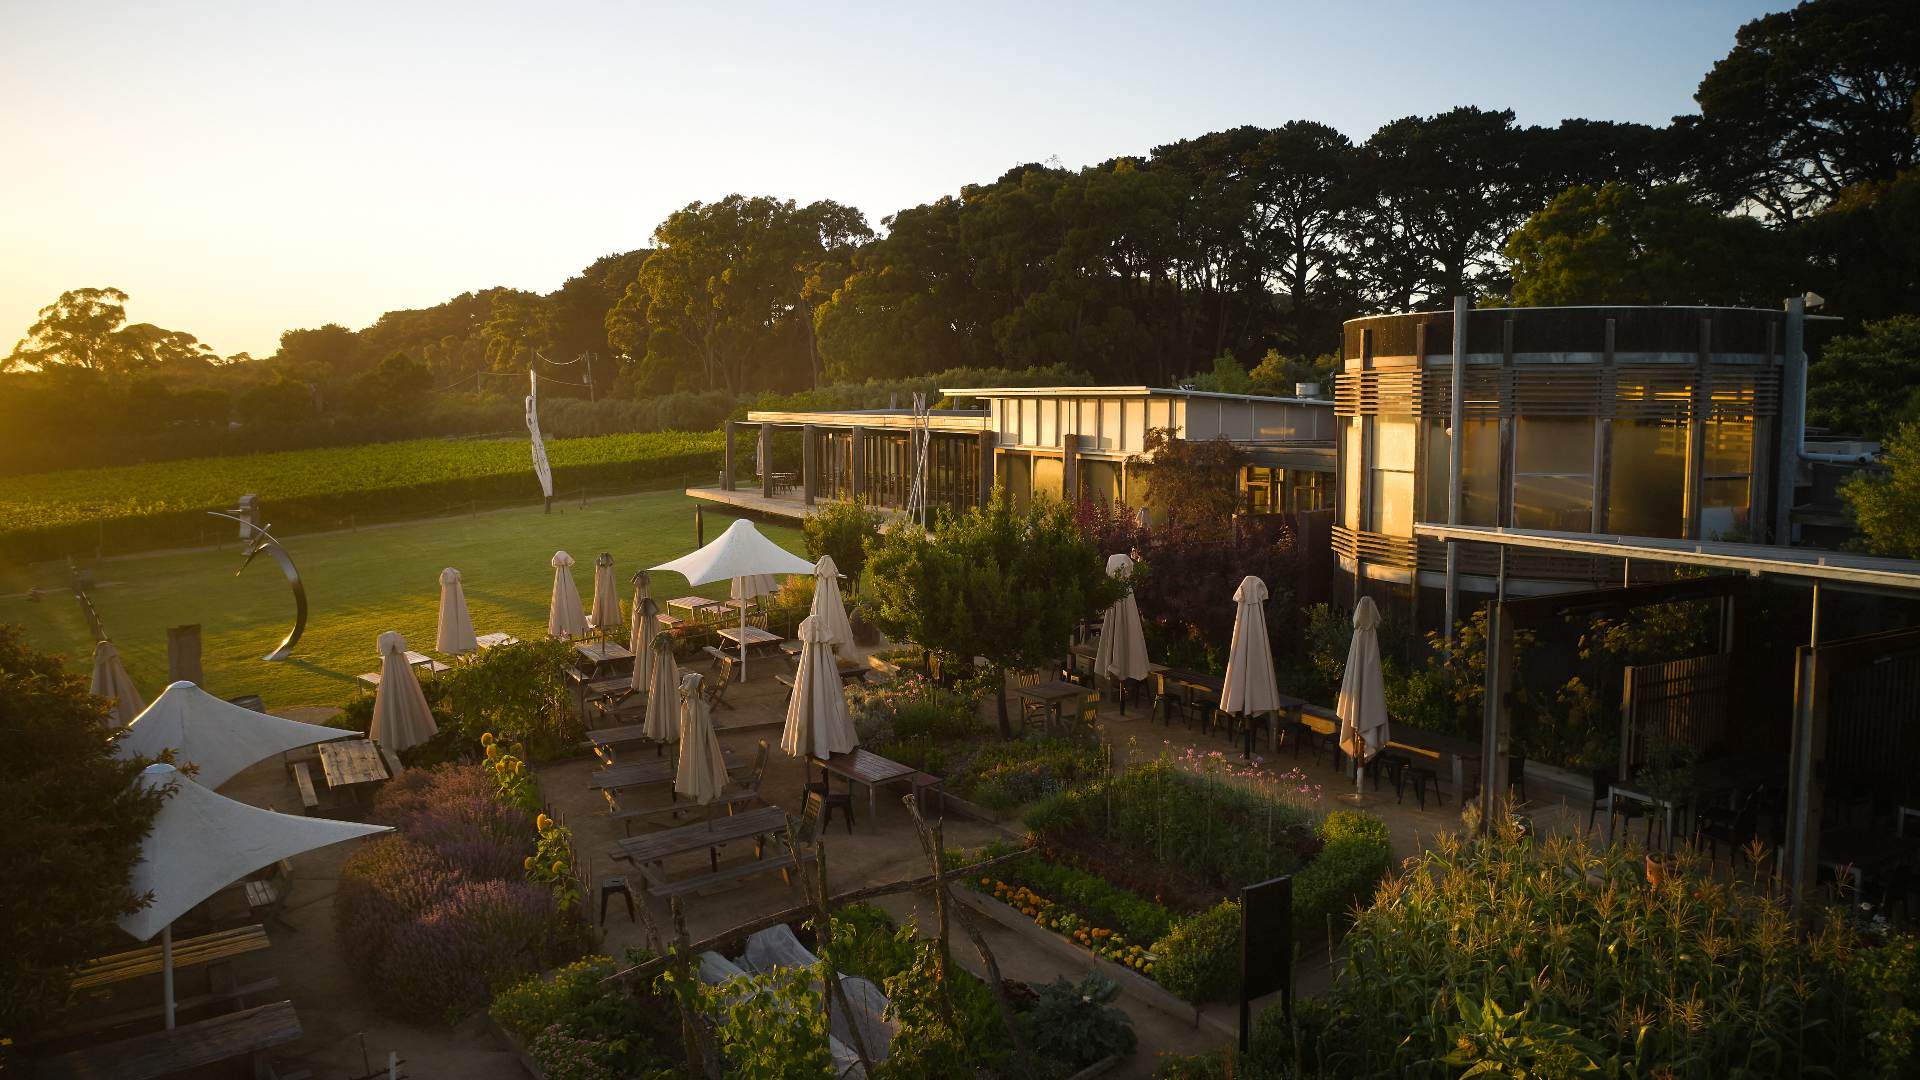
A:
1334 306 1805 603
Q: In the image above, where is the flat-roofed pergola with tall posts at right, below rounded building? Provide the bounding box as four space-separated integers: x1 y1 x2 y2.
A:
1413 523 1920 896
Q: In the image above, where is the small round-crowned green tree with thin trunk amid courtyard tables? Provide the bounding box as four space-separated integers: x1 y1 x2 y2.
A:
868 488 1123 738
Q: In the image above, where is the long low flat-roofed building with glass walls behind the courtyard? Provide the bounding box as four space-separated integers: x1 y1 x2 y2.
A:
687 386 1334 517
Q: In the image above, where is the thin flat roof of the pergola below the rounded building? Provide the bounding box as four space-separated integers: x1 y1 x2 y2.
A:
1413 523 1920 592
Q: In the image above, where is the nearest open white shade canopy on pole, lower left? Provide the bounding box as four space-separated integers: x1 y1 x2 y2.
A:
119 760 392 1028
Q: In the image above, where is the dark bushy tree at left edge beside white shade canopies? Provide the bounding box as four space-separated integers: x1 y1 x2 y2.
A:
0 626 165 1038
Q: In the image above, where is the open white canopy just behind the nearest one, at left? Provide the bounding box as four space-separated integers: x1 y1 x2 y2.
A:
113 680 357 788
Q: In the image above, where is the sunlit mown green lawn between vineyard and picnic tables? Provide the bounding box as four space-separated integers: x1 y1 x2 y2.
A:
0 492 804 709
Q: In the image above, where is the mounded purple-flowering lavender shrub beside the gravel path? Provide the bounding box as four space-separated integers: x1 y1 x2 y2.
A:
334 765 591 1022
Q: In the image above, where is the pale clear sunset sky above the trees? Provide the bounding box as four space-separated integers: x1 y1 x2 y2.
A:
0 0 1788 356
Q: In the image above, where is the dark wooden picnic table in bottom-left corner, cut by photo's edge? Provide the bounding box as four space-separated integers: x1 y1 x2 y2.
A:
35 1001 301 1080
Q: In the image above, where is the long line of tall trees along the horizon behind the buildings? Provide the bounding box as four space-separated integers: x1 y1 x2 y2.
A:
0 0 1920 469
